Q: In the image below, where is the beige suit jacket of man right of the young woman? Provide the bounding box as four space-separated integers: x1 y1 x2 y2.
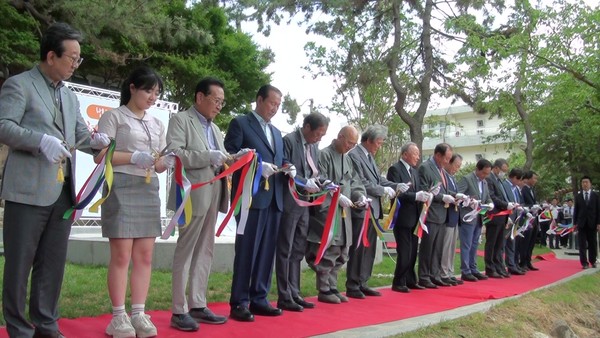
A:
167 108 229 216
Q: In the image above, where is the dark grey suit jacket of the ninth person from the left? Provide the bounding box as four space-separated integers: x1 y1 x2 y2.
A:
419 159 449 224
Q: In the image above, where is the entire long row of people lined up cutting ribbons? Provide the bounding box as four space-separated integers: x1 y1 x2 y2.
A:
0 23 600 337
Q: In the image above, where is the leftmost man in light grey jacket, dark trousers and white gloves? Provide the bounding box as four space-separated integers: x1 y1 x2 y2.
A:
0 23 110 337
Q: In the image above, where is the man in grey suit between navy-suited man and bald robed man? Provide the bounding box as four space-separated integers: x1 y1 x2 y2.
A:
275 113 329 311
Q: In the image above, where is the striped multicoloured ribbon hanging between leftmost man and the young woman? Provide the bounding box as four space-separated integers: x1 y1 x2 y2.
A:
63 140 116 221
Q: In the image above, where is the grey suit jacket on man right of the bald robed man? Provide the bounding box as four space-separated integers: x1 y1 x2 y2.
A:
348 146 398 219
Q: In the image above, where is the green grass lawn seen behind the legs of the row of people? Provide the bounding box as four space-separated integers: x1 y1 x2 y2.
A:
0 240 549 325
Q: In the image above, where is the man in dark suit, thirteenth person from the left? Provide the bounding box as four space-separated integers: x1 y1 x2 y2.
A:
502 168 525 275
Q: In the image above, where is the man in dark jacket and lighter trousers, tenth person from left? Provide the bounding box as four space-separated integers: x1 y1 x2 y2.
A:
441 154 465 286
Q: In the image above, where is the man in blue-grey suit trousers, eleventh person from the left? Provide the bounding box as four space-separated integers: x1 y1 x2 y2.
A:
458 159 492 282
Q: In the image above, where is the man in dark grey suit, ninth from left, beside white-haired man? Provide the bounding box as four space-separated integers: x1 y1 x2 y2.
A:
418 143 455 289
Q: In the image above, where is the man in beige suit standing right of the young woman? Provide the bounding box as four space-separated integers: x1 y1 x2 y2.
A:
167 77 229 331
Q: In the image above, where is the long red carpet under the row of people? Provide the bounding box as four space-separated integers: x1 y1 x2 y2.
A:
0 255 581 338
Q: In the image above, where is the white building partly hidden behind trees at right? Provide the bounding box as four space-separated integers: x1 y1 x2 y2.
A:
423 105 518 164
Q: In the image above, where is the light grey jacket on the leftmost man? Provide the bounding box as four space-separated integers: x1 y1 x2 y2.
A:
0 66 91 206
